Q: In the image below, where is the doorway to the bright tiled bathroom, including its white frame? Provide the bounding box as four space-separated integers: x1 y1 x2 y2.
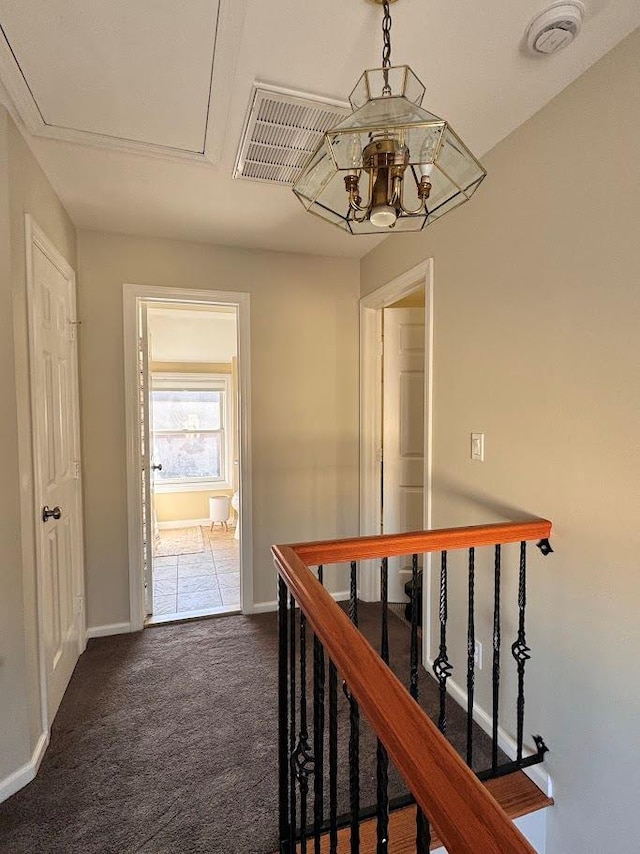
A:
125 286 252 628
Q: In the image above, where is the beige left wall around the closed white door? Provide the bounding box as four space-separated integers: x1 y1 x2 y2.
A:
0 107 76 780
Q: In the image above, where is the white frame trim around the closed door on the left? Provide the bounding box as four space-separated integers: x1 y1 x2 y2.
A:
24 213 87 742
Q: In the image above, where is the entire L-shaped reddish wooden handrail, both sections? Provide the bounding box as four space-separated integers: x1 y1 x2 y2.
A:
272 520 551 854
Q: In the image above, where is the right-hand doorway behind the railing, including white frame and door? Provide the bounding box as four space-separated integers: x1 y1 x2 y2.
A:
360 260 433 620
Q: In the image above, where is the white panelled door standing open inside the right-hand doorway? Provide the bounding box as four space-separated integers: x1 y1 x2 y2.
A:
382 308 425 602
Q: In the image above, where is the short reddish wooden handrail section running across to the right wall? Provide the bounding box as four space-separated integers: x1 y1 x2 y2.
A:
291 519 551 566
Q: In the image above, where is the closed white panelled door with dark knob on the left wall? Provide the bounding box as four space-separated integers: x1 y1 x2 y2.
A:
27 219 85 724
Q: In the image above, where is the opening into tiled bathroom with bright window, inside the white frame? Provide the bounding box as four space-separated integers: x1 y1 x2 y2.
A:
140 301 242 623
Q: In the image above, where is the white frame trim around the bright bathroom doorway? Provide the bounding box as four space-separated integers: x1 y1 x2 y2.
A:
123 284 254 632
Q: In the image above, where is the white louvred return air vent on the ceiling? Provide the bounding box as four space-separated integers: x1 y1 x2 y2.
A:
233 83 351 184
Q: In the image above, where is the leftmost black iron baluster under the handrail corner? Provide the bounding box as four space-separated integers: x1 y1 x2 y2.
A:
278 576 295 852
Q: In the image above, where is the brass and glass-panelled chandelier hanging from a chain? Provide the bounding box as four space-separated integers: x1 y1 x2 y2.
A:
293 0 487 234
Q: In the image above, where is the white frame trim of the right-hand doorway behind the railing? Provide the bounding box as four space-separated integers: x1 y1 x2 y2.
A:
360 258 434 608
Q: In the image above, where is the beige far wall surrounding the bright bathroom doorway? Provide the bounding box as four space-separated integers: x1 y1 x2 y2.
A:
79 232 359 626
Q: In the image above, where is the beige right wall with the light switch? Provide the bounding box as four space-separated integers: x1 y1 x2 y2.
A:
361 31 640 854
